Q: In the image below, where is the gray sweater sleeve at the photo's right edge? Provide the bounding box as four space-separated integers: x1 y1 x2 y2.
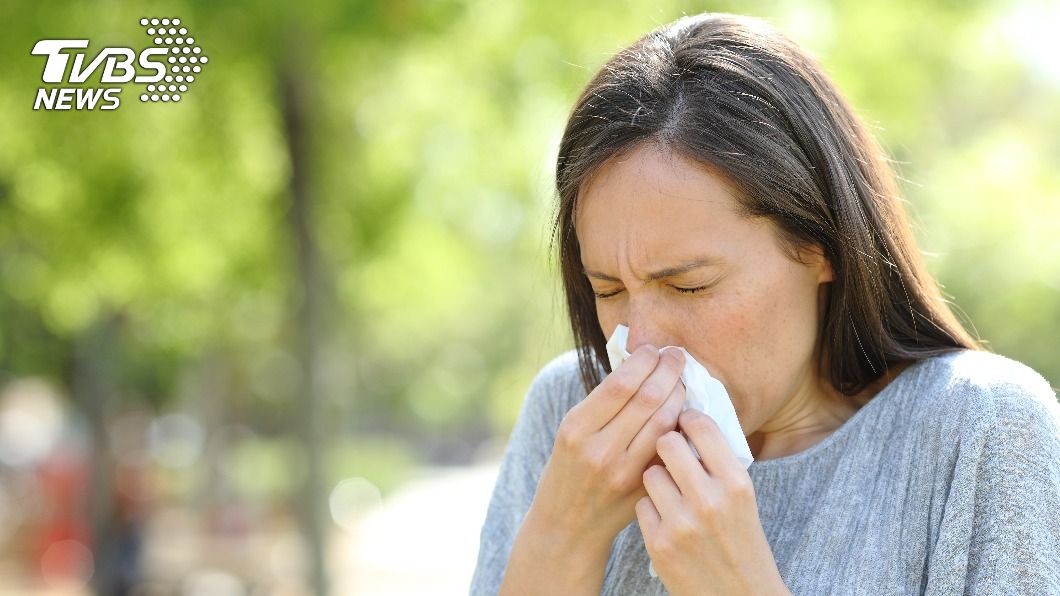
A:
926 365 1060 596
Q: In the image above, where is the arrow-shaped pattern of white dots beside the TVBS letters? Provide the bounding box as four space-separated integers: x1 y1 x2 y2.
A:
140 17 209 103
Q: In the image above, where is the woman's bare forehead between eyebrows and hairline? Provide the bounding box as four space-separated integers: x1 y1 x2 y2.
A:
575 143 754 259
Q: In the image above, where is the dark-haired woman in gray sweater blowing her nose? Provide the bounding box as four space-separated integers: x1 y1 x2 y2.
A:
471 10 1060 596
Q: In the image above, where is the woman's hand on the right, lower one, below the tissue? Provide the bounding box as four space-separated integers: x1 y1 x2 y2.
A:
636 409 789 596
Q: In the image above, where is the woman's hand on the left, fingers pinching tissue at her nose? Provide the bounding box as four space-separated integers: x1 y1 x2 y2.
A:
527 346 685 553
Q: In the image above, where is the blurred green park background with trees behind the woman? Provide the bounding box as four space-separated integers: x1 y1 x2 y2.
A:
0 0 1060 595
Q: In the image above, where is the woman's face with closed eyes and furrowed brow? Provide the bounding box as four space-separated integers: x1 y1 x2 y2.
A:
576 142 832 435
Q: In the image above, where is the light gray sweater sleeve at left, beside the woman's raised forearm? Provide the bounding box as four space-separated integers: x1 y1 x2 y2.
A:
471 352 577 596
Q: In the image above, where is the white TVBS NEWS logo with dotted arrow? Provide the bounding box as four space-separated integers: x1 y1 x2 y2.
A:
32 18 210 110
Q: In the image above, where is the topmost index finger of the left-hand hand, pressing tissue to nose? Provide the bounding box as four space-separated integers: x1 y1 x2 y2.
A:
567 344 659 433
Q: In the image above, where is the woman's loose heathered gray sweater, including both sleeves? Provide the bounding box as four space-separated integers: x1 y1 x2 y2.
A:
471 350 1060 596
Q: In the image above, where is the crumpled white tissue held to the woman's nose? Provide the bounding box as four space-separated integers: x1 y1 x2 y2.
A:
607 325 755 577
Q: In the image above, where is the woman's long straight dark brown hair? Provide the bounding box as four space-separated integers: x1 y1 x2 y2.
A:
549 14 985 396
